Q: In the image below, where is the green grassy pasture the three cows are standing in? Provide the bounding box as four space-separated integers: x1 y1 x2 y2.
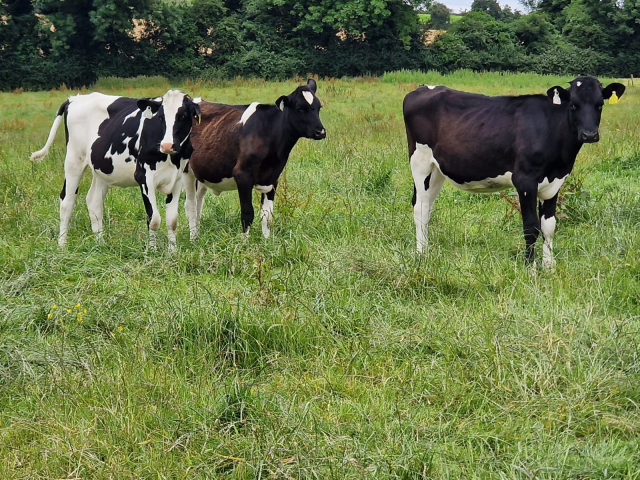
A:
0 72 640 480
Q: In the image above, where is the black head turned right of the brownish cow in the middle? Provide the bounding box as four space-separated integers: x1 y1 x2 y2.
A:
276 78 327 140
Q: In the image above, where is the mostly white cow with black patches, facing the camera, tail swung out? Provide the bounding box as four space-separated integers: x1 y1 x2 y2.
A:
31 90 200 250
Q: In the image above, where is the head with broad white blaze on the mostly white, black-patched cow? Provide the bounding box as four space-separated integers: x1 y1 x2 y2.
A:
138 90 200 155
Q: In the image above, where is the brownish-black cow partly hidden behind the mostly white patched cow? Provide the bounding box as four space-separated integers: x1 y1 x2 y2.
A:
184 79 326 240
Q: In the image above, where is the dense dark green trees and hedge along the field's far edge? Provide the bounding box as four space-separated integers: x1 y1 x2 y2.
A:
0 0 640 90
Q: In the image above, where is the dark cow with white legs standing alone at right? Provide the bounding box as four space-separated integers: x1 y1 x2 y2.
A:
403 77 625 268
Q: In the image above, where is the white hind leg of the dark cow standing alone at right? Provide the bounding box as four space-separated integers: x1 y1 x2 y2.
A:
411 145 445 253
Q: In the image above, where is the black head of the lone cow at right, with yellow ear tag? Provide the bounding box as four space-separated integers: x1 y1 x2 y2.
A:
547 77 625 143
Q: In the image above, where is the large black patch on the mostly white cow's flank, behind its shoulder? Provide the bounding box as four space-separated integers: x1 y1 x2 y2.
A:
91 97 142 175
